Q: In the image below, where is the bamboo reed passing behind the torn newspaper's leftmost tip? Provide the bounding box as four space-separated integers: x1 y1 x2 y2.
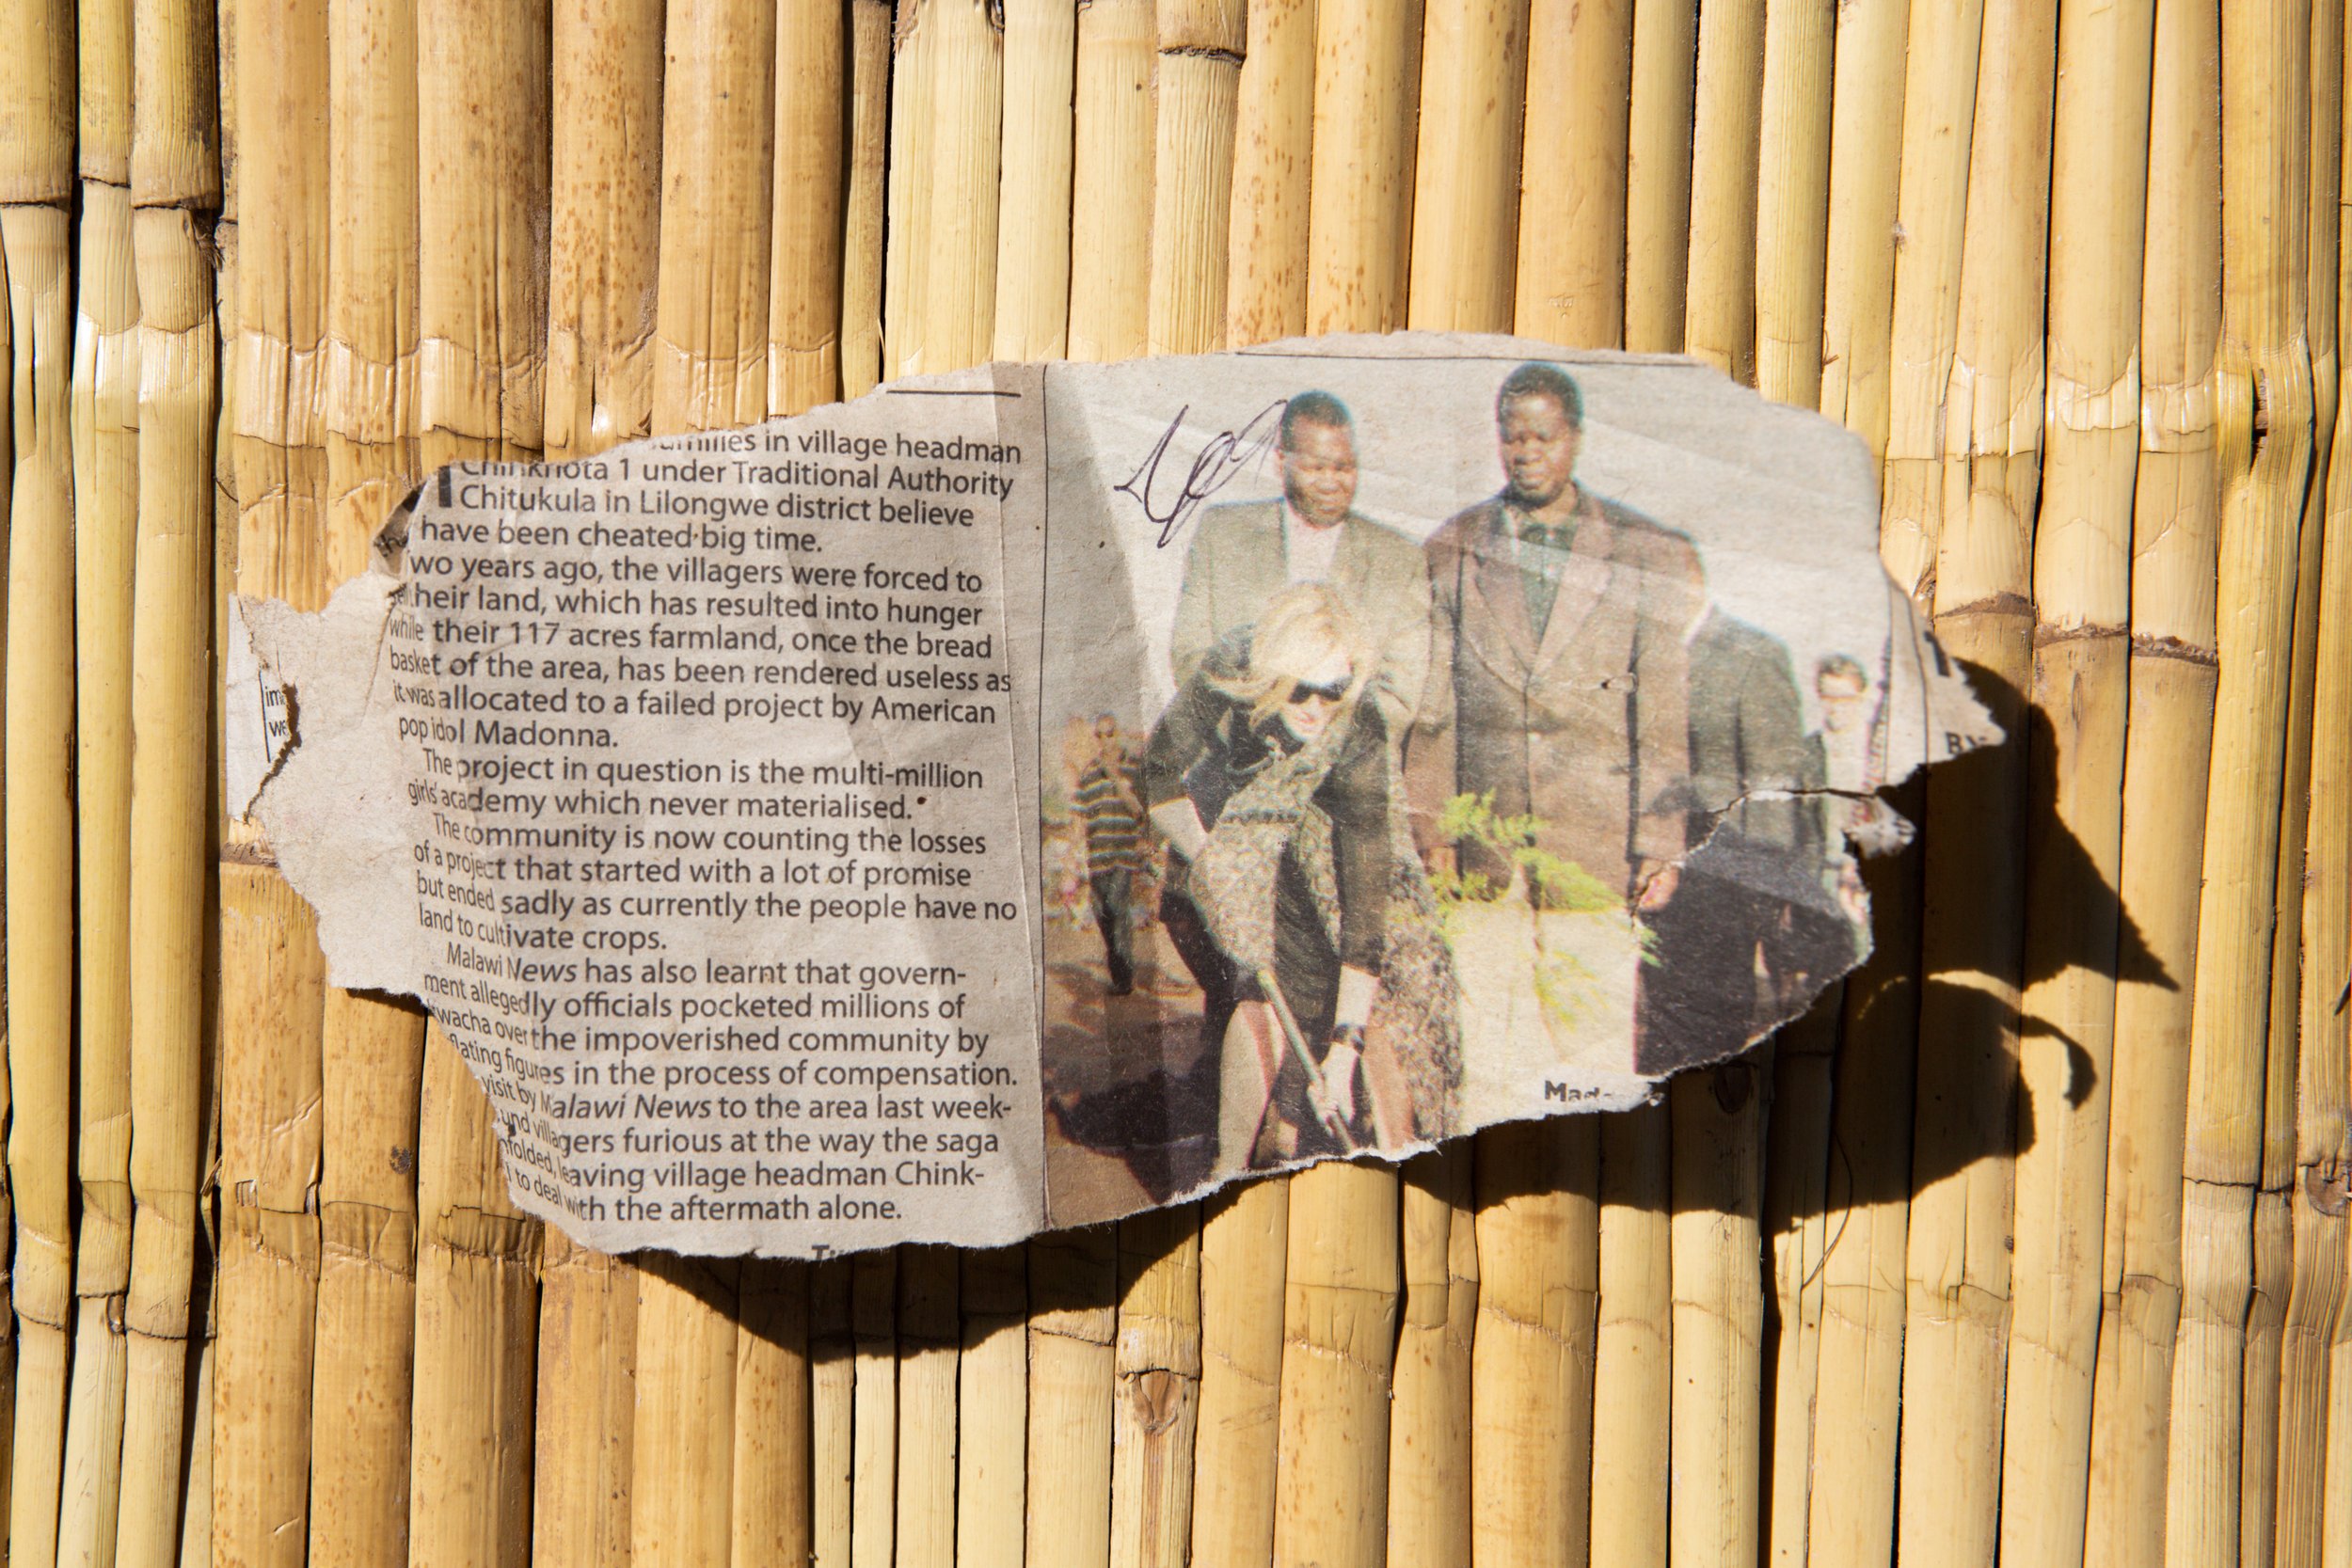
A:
215 0 329 1563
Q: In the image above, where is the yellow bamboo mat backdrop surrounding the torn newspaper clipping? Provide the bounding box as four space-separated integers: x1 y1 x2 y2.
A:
0 0 2352 1568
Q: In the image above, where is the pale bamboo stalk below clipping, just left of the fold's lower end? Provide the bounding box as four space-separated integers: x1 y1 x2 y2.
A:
955 1246 1028 1568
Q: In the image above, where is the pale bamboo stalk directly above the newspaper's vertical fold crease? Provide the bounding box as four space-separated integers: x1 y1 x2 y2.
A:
993 0 1077 359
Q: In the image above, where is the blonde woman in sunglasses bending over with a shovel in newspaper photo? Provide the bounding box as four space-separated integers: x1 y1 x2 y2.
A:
1143 583 1461 1171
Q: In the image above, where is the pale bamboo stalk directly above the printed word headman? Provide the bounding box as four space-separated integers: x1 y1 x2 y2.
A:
917 0 1005 369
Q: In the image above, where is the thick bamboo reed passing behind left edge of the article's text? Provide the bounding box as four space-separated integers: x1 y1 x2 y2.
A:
409 0 550 1563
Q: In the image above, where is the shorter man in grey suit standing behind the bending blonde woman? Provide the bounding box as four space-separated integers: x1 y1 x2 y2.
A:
1169 392 1430 738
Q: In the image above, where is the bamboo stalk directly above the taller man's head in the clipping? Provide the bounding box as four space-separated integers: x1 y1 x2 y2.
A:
1505 0 1635 345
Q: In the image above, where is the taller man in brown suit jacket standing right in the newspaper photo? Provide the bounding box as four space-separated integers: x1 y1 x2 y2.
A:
1405 362 1706 910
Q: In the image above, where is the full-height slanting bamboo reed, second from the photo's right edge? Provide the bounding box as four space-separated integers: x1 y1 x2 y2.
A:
2167 0 2312 1563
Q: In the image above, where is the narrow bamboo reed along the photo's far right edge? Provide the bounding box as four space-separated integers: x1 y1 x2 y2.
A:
2265 0 2352 1568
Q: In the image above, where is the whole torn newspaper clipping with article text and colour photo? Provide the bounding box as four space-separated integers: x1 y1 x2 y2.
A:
226 336 1999 1258
